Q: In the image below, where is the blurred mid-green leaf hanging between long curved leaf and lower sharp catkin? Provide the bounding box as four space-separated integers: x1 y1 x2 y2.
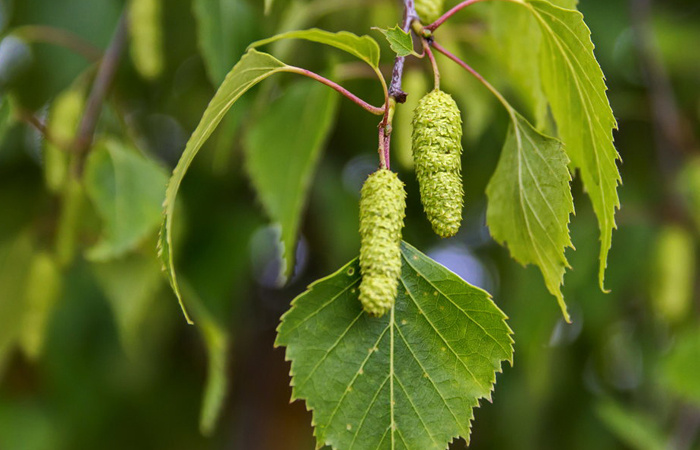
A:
245 81 340 282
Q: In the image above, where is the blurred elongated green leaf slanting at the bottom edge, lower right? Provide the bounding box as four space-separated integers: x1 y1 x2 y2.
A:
597 400 668 450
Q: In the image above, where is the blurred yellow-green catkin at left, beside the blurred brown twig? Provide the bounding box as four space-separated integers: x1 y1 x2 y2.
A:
44 87 85 193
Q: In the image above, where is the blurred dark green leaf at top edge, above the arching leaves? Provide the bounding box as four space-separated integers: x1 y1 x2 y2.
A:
192 0 255 86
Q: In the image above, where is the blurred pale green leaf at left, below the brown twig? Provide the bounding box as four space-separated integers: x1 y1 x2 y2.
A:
85 140 167 261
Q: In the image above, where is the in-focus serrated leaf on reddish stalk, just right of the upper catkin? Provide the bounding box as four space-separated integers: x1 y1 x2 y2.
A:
486 113 574 321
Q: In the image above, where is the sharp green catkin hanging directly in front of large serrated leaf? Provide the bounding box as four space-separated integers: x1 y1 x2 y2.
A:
360 169 406 317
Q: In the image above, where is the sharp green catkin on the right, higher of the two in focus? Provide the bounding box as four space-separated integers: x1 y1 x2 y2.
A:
412 89 464 237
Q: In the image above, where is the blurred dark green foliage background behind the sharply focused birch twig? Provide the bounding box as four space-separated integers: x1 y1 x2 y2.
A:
0 0 700 450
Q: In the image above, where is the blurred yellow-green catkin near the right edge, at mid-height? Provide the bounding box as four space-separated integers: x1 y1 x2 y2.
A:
650 225 695 323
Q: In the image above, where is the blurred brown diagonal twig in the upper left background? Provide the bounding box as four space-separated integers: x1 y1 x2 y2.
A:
73 13 128 176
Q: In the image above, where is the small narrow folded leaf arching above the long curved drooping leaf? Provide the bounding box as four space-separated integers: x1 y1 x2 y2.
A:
248 28 379 69
